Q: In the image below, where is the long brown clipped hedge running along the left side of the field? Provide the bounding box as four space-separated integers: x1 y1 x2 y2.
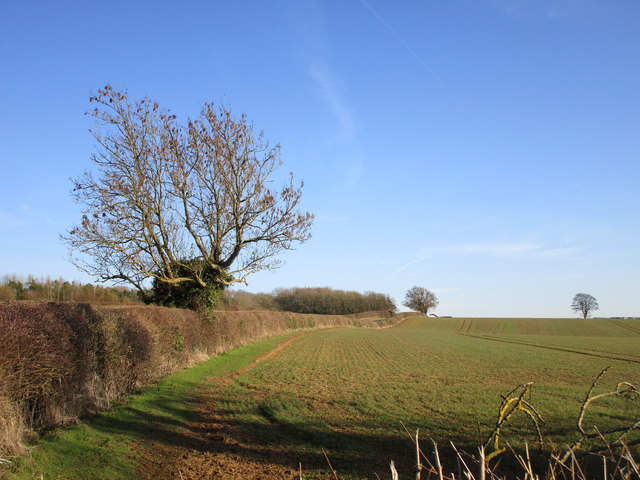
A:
0 302 406 455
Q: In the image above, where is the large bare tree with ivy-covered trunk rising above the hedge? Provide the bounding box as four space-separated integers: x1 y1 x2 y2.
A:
63 85 313 306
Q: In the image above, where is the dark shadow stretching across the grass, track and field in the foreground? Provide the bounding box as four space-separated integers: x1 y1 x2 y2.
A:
71 388 436 478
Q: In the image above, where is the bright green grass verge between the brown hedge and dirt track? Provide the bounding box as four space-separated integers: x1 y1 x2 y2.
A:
0 334 293 480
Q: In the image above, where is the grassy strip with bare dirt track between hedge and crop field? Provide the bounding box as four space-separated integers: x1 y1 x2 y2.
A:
0 334 299 480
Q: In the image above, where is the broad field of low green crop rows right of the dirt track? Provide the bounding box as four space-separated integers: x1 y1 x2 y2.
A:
217 318 640 478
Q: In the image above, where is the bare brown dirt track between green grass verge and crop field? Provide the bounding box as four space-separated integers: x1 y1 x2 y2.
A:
134 332 324 480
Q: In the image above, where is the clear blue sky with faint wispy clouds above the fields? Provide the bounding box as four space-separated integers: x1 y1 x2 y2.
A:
0 0 640 316
